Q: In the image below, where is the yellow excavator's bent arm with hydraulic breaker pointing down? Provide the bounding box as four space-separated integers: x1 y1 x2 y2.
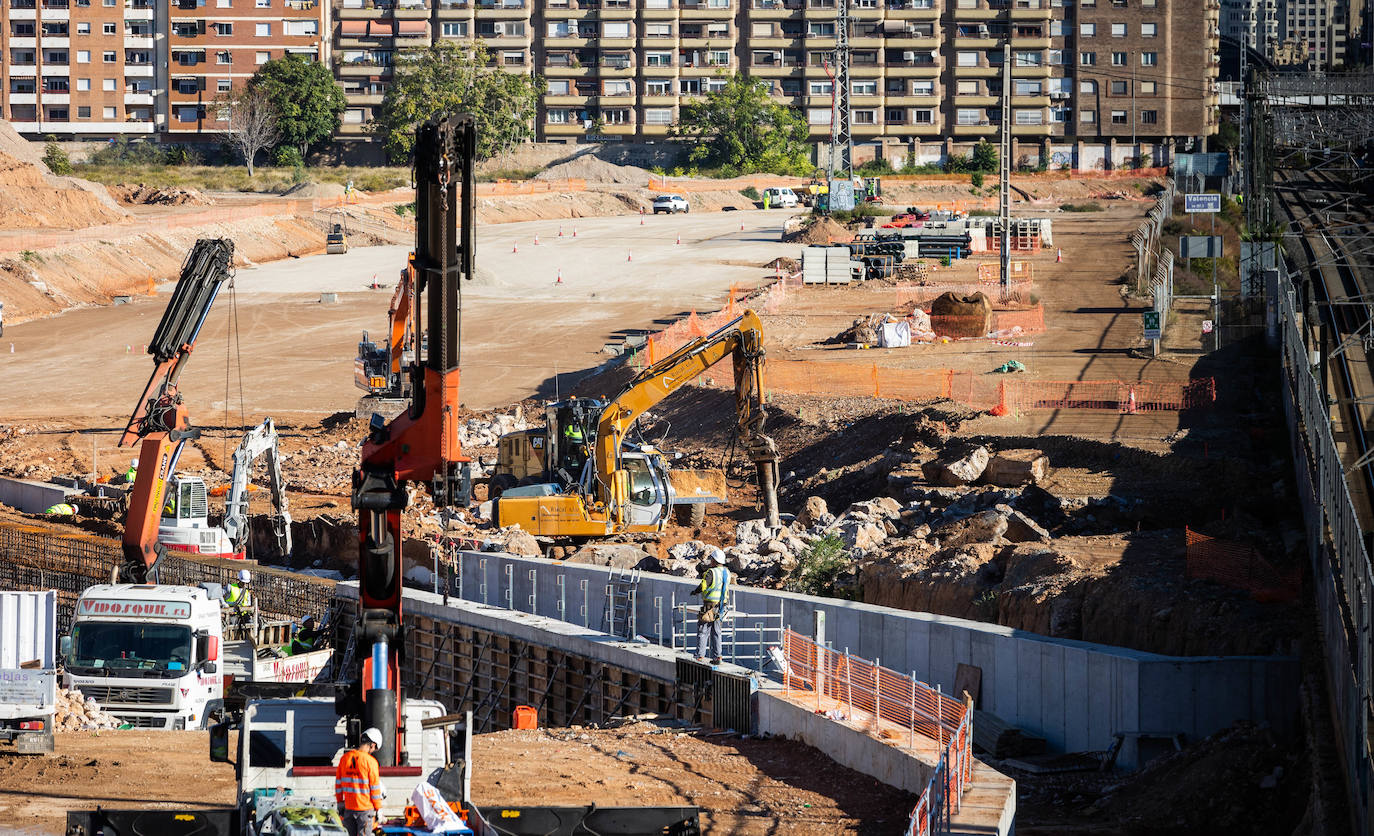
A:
596 311 779 528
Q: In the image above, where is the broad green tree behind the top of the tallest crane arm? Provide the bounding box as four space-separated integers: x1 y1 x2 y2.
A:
371 41 544 162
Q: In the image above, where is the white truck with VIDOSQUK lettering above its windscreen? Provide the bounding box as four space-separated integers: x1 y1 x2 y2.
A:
60 583 333 729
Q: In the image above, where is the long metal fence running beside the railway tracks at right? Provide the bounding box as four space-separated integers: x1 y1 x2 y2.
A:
1272 268 1374 833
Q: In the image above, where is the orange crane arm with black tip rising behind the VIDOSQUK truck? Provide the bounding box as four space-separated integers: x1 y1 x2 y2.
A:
117 238 234 583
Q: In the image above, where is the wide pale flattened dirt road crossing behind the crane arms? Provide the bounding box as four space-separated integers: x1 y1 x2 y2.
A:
0 210 794 421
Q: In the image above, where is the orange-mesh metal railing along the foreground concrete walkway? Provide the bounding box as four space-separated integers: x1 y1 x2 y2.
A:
780 630 973 836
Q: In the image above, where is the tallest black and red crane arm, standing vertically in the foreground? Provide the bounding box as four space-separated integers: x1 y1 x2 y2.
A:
353 114 477 767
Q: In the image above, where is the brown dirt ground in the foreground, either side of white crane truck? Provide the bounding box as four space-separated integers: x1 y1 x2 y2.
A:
0 722 915 836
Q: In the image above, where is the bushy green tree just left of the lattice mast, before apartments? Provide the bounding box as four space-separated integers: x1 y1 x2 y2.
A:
673 73 809 173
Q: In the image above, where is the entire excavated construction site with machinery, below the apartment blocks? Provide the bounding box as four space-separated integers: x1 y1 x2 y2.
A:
0 81 1369 836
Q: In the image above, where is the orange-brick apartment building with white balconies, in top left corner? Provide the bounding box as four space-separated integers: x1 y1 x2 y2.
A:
0 0 161 136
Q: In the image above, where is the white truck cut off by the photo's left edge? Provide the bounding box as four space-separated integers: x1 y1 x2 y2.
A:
0 590 58 755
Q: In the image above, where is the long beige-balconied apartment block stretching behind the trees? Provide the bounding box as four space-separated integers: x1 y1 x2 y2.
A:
334 0 1220 157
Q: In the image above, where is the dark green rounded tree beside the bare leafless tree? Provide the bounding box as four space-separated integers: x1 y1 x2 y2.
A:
249 55 346 160
